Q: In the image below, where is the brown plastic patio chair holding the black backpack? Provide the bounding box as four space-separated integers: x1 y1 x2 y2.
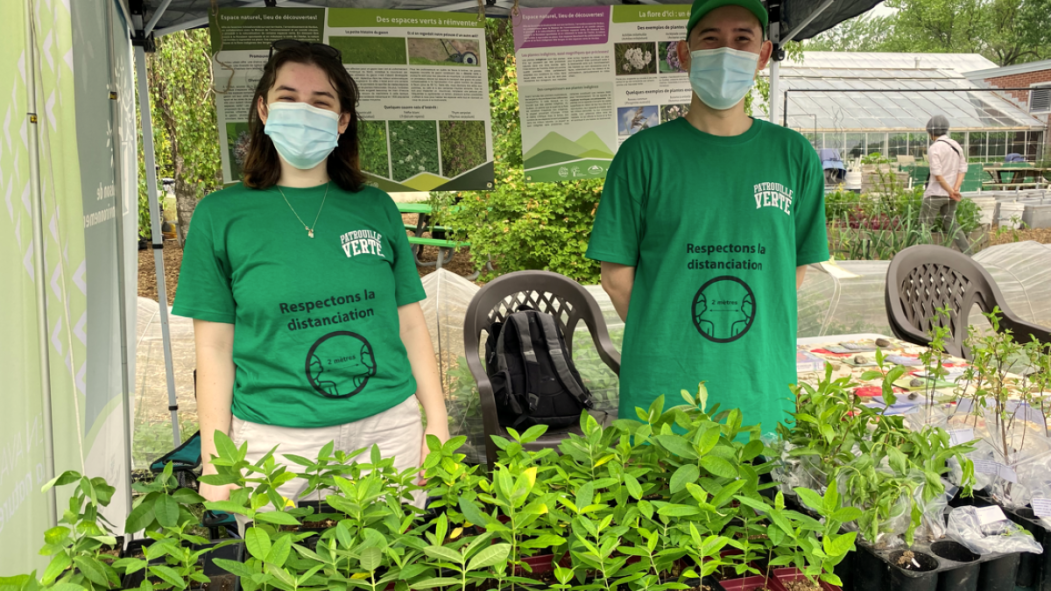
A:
463 271 620 470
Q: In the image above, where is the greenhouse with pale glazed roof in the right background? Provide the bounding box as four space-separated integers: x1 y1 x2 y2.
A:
765 52 1046 162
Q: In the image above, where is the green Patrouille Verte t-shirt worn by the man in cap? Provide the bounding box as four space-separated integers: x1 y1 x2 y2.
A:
588 119 828 432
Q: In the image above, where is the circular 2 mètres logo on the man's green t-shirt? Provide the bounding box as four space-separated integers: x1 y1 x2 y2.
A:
692 276 756 343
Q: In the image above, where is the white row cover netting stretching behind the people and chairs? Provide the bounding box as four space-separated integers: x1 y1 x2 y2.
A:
132 242 1051 468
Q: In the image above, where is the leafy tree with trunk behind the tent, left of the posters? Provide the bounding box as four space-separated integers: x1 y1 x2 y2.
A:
140 28 223 244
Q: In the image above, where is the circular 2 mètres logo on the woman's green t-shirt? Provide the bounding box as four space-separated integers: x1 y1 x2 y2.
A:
307 330 376 399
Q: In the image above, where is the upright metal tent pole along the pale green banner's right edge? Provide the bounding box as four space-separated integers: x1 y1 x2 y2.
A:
106 0 139 514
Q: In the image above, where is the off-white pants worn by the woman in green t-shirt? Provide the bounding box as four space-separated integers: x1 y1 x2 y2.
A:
230 396 425 525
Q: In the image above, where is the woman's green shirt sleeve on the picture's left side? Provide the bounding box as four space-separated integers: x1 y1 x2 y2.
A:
171 197 236 324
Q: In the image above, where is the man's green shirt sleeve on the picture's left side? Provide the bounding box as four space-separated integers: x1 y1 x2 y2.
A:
585 139 645 267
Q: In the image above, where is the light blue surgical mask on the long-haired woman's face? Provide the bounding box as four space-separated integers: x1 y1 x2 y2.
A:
263 102 339 170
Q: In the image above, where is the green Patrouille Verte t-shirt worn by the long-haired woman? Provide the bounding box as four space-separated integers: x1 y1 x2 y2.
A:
172 183 427 428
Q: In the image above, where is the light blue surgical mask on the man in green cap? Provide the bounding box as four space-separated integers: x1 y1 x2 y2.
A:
689 47 759 110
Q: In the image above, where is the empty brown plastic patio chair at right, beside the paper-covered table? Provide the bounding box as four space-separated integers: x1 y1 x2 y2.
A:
886 244 1051 361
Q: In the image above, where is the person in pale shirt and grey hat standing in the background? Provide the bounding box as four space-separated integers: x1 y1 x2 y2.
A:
920 115 971 252
